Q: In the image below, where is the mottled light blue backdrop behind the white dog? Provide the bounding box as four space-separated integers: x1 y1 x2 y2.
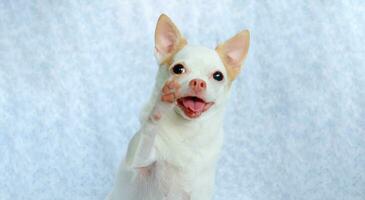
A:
0 0 365 200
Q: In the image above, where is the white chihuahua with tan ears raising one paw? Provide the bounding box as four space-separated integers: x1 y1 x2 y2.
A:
107 14 249 200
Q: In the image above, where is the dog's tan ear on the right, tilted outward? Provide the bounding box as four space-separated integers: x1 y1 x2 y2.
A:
215 30 250 80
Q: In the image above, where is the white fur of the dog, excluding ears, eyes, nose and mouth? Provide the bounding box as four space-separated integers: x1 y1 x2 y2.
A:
108 46 230 200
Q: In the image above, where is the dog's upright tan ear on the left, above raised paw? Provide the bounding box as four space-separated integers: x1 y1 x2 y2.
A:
155 14 187 63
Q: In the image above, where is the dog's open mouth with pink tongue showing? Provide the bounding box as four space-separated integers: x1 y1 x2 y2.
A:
177 96 214 118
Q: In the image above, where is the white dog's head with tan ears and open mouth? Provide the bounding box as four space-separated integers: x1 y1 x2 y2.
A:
155 14 249 119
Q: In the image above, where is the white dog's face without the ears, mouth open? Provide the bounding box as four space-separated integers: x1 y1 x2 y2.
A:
168 46 229 119
